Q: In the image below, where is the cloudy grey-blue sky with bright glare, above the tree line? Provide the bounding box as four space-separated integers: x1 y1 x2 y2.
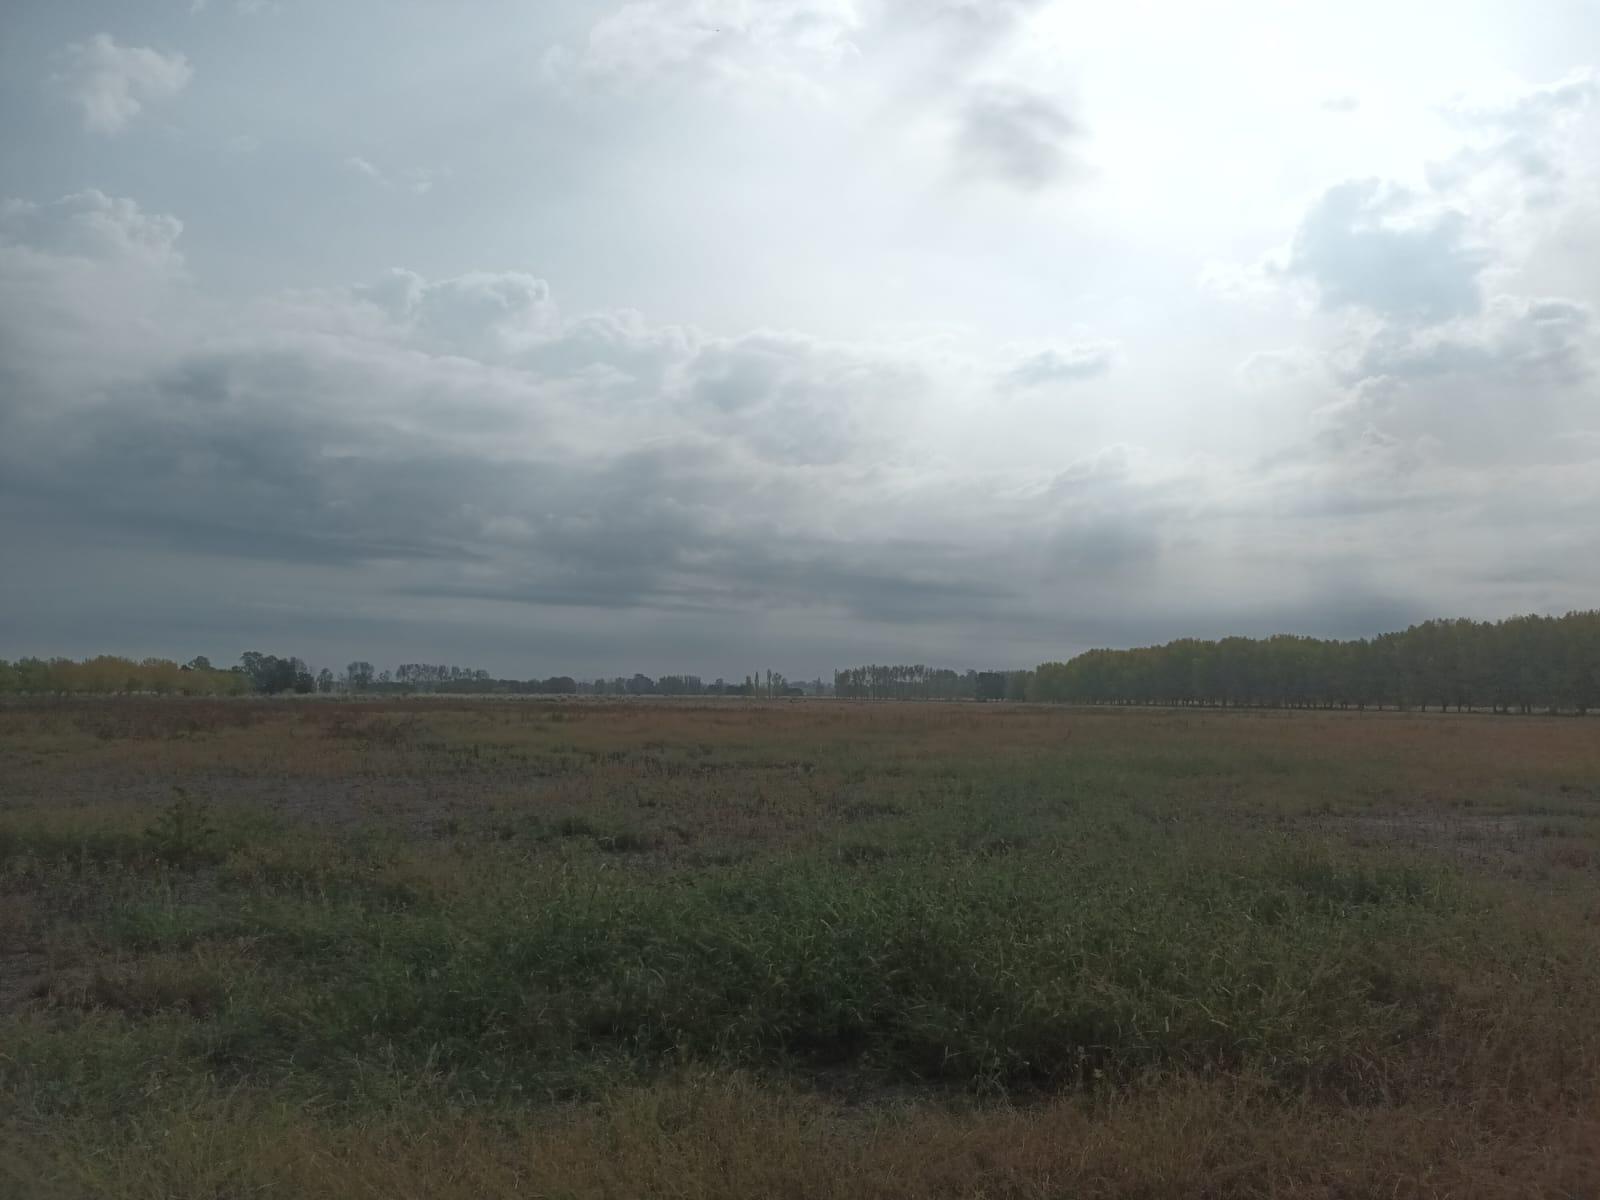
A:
0 0 1600 678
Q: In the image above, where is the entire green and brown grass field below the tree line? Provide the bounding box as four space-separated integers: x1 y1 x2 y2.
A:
0 699 1600 1200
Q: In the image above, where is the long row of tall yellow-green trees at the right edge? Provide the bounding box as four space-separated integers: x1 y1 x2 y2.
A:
1029 611 1600 712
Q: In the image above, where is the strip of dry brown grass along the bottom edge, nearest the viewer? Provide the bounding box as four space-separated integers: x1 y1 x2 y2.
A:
12 1077 1600 1200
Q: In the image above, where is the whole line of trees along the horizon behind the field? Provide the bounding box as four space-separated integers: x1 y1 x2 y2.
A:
0 611 1600 712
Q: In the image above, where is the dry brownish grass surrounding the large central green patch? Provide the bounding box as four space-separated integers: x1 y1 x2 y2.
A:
0 699 1600 1200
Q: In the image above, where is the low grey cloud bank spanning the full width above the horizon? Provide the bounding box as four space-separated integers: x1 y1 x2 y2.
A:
0 175 1600 674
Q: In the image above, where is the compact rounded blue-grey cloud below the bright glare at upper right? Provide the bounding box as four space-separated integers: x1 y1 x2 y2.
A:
1286 179 1490 323
